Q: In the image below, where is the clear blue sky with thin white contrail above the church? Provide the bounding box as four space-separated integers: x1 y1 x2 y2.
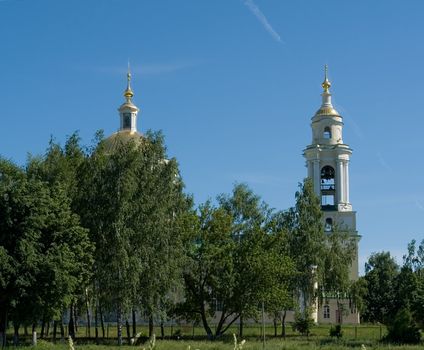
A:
0 0 424 274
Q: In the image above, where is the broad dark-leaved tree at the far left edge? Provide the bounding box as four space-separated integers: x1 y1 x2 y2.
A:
0 160 91 346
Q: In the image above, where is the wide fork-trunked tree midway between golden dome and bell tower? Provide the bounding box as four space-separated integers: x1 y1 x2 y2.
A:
180 185 292 338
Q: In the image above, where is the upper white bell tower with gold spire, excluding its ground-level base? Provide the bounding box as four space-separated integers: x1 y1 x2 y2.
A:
303 65 359 280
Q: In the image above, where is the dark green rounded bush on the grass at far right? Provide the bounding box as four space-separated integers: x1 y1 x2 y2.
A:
384 308 421 344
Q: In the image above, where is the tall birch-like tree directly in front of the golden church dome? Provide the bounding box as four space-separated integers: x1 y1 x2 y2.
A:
79 133 187 343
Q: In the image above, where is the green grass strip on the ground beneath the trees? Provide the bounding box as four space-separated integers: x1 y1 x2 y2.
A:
8 324 424 350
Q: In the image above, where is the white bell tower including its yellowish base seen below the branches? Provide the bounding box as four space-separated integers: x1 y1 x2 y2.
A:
303 66 360 324
